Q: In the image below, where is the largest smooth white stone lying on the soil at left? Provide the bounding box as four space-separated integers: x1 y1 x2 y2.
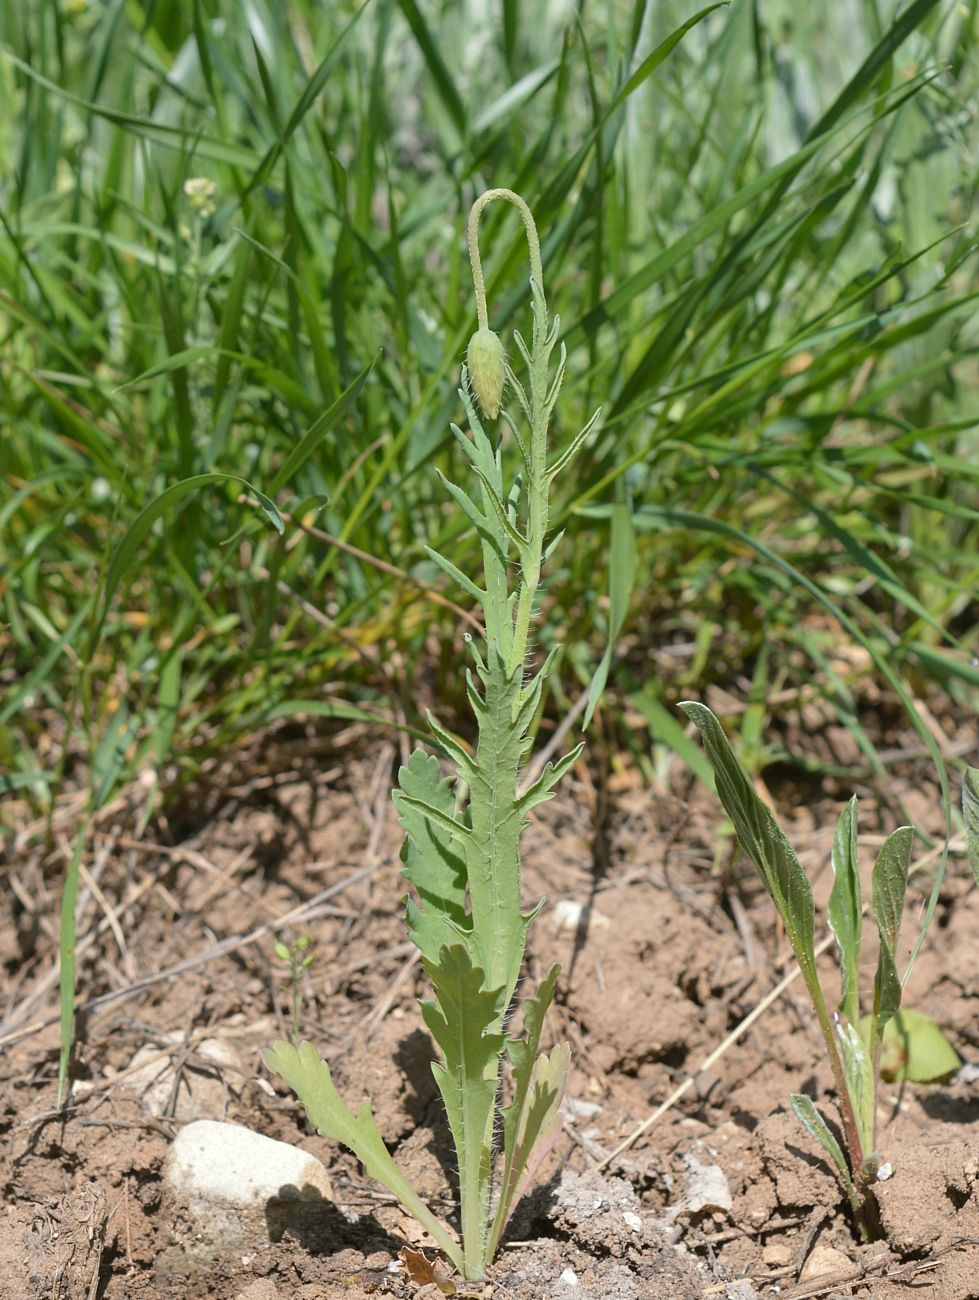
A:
164 1119 333 1240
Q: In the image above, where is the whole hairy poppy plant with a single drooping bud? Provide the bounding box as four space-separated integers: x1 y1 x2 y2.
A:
265 190 598 1281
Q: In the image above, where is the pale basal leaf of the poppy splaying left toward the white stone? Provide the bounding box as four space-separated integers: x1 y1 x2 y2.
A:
264 1043 463 1269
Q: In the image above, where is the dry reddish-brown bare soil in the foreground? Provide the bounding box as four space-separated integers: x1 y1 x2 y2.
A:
0 709 979 1300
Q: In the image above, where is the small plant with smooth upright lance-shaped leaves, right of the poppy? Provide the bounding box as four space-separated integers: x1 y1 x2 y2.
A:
680 702 915 1239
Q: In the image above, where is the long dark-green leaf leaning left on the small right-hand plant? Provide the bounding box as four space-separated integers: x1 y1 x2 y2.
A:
680 701 819 993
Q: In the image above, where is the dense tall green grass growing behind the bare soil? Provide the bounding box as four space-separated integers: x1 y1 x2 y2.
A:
0 0 979 815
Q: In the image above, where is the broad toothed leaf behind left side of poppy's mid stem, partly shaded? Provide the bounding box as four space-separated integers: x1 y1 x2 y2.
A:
394 749 469 961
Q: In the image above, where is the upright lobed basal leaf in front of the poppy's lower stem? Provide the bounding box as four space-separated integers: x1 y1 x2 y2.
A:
421 944 504 1257
